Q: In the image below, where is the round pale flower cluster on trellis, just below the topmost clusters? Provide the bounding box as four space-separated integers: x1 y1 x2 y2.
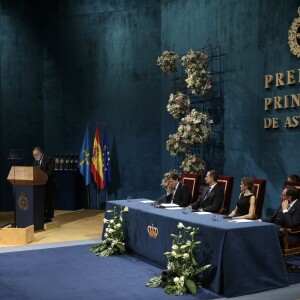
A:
167 92 191 119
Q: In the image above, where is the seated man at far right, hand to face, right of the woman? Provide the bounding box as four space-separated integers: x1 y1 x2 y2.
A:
262 186 300 245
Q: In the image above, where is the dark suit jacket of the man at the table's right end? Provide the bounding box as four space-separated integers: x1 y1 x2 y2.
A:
262 199 300 243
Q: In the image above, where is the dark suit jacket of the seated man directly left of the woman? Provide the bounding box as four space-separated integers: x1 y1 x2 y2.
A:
192 184 224 213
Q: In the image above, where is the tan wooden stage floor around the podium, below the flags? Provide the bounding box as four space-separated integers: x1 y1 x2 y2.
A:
0 209 104 248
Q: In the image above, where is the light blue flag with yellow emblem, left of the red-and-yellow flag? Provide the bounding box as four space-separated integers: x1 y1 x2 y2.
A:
78 127 91 185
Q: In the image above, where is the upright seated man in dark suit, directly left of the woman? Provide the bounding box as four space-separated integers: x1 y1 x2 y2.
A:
191 170 224 213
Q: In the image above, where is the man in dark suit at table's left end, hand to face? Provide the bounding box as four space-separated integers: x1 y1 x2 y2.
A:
167 173 192 207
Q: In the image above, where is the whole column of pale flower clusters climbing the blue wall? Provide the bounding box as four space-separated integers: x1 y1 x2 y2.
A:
157 50 213 186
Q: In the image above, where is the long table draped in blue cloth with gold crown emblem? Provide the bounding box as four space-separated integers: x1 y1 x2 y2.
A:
106 199 288 297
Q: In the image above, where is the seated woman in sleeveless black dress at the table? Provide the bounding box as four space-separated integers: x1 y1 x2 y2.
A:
228 177 255 219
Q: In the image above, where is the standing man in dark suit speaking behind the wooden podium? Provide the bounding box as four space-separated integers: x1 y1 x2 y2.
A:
32 147 56 223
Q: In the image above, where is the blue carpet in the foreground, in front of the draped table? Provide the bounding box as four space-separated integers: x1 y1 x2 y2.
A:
0 245 220 300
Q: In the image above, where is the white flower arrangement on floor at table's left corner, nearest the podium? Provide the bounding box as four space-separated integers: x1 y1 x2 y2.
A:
91 207 129 256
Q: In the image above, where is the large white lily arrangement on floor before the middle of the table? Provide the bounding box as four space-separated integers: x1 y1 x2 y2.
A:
146 223 210 296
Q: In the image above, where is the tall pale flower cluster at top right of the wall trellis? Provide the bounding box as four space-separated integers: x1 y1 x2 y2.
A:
181 49 212 96
